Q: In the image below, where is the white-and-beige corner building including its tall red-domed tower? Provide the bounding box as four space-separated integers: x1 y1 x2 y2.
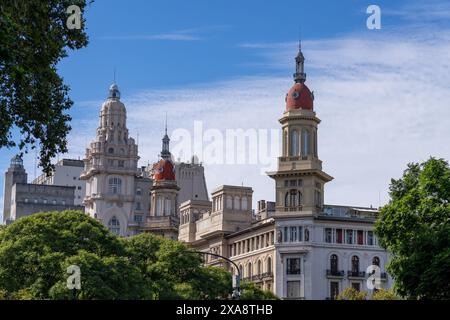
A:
179 45 392 299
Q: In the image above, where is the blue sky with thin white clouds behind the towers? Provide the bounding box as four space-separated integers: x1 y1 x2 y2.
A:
0 0 450 221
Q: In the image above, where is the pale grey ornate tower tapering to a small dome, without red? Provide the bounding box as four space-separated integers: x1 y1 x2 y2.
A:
80 83 139 236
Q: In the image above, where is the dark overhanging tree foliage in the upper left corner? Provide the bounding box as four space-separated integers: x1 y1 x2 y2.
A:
0 0 92 173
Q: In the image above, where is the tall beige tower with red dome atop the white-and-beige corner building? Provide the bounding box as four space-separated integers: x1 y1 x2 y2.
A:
268 45 333 216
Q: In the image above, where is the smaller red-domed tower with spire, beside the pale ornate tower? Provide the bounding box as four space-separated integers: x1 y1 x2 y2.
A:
145 129 180 240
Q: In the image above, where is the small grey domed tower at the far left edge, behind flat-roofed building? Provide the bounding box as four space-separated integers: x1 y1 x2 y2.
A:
3 155 28 223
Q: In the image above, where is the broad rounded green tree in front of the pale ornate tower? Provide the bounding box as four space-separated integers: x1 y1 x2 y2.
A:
0 211 137 299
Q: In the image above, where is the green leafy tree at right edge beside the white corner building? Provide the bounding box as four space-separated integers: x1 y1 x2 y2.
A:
376 158 450 299
